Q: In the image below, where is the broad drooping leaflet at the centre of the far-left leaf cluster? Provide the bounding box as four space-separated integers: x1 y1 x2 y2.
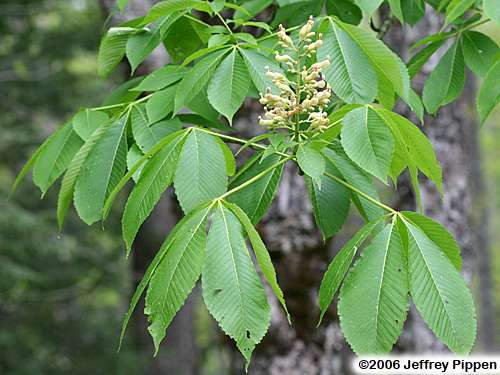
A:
74 115 128 225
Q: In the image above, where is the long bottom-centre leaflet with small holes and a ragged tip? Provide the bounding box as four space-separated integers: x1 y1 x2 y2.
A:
202 204 271 364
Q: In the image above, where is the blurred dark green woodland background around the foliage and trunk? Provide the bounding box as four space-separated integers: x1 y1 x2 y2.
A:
0 0 500 375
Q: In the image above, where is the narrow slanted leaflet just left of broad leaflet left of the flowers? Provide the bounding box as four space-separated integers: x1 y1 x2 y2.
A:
174 49 228 113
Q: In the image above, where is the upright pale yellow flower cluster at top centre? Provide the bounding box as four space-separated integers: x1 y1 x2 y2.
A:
259 17 332 137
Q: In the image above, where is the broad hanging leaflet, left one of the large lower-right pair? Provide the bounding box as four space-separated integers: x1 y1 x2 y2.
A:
338 220 408 355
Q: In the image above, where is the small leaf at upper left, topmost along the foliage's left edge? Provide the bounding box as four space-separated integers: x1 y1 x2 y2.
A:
97 27 137 76
